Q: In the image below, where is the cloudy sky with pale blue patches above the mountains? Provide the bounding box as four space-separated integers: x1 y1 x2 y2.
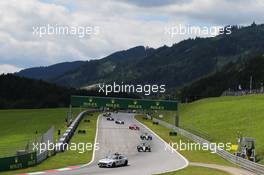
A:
0 0 264 73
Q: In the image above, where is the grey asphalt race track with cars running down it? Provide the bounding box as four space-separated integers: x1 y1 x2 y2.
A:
48 113 188 175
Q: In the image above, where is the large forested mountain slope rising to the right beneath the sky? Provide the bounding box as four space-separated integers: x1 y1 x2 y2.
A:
18 24 264 89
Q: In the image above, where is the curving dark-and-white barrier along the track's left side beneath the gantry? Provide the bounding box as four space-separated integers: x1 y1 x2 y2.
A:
56 109 101 152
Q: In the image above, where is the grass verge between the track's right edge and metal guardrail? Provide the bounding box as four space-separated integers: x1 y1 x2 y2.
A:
136 115 234 166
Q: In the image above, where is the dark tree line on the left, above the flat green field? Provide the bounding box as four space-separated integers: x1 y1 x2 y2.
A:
0 74 139 109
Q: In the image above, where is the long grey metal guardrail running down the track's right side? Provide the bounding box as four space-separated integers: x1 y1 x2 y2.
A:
147 116 264 175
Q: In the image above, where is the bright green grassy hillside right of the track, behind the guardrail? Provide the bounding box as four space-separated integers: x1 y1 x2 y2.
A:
154 95 264 163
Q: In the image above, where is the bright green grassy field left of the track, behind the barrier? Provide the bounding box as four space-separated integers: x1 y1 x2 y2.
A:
0 108 79 157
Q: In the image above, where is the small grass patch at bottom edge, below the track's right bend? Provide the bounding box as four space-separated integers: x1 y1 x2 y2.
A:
158 166 230 175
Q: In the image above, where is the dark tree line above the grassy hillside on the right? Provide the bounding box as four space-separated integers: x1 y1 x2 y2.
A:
179 56 264 101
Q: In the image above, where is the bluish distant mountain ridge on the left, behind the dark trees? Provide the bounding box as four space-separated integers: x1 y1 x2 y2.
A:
16 46 154 87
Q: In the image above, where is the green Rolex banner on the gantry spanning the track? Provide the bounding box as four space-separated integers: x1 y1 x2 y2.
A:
71 96 178 110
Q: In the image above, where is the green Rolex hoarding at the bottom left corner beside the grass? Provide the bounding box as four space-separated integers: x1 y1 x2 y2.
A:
0 152 37 171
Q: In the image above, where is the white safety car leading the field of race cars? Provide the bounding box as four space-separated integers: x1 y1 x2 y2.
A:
98 153 128 168
